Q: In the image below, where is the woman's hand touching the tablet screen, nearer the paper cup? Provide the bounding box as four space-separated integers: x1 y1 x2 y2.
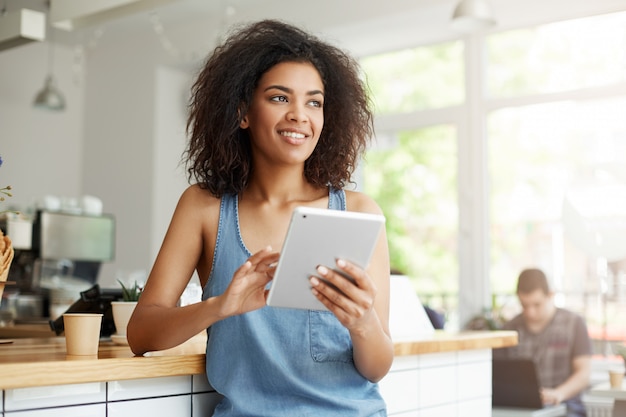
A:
219 246 280 318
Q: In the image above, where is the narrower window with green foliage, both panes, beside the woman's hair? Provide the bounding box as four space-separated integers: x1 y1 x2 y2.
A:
362 42 464 318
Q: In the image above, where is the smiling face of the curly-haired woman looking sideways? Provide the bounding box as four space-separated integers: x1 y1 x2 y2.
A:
240 62 324 164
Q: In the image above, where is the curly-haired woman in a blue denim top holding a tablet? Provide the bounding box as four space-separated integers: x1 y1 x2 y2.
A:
127 21 393 417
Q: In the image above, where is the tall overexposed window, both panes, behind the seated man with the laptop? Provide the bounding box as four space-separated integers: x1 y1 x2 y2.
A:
486 13 626 353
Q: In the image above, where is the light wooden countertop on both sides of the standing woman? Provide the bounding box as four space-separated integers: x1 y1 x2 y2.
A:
0 331 517 389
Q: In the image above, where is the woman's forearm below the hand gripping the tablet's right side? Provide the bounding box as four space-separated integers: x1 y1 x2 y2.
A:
351 316 393 382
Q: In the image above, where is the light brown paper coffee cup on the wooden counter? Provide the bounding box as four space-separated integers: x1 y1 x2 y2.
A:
63 313 102 356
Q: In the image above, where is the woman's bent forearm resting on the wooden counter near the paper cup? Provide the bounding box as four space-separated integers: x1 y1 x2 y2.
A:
127 299 220 355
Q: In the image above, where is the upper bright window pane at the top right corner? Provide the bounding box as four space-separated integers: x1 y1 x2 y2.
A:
486 13 626 97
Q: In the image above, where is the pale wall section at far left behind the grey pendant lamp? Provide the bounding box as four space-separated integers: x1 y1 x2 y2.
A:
0 39 84 209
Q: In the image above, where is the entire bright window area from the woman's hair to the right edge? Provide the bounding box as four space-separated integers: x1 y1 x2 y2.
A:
362 8 626 342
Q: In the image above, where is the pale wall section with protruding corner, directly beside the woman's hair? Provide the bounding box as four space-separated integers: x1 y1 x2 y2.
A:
83 35 189 287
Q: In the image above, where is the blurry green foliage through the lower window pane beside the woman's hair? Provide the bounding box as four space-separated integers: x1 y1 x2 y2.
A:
363 126 458 294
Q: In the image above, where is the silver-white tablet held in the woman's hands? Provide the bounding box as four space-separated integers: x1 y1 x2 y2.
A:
267 207 385 310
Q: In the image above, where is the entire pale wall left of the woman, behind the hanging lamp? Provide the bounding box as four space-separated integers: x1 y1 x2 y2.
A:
0 32 190 287
